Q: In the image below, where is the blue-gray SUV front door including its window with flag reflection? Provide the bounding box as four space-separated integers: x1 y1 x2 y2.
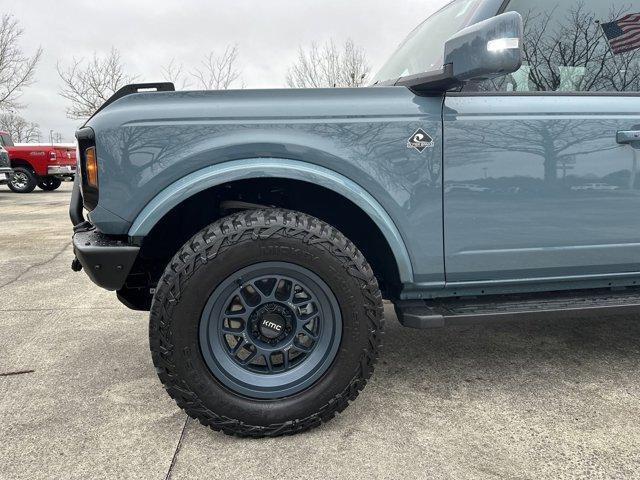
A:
443 0 640 283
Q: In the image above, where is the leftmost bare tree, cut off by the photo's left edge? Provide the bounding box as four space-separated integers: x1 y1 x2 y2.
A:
0 14 42 110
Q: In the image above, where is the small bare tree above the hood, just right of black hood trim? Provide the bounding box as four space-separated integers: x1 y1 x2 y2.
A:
191 45 242 90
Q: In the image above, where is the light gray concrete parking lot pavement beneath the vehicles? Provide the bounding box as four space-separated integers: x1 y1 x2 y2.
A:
0 183 640 480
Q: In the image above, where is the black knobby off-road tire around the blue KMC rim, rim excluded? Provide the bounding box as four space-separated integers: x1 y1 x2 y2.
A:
149 209 384 437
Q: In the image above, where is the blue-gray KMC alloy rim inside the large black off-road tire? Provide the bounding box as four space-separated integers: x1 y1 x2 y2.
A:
200 262 342 398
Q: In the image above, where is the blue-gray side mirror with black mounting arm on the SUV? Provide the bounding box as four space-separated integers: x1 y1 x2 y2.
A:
396 12 523 93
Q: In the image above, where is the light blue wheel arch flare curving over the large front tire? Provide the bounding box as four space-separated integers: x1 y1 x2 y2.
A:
129 158 413 283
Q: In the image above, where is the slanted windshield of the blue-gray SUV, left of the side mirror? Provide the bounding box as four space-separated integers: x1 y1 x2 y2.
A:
373 0 482 84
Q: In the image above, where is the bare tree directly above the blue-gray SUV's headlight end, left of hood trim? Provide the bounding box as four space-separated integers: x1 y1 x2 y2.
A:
56 48 135 119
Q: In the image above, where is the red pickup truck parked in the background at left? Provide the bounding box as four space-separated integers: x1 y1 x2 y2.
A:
0 131 76 193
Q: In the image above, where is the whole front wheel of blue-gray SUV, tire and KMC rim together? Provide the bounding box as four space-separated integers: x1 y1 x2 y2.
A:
150 209 383 437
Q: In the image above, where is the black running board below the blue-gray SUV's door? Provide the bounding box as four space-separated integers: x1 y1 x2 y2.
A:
395 288 640 329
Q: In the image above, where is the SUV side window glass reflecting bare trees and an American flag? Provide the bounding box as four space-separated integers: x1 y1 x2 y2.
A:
465 0 640 92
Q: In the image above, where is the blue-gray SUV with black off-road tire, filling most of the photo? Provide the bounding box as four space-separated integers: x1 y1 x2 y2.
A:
70 0 640 437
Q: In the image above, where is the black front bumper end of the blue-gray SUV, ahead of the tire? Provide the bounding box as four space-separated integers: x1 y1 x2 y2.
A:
73 227 140 290
